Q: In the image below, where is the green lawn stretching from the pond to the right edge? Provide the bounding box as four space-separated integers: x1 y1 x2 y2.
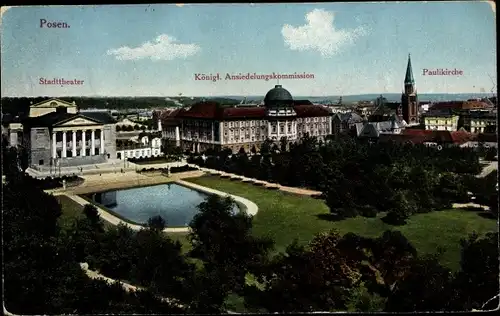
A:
186 176 497 270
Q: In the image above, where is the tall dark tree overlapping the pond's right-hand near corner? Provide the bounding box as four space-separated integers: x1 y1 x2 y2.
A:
189 195 273 312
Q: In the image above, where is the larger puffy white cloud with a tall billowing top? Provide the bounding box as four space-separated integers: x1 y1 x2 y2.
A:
281 9 367 57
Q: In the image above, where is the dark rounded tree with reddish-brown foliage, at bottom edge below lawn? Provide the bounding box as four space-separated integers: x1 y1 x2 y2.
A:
253 231 361 313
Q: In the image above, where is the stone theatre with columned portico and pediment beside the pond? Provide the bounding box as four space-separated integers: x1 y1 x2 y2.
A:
3 99 116 169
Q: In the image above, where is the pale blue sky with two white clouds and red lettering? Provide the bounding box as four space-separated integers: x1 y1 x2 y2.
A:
0 1 497 97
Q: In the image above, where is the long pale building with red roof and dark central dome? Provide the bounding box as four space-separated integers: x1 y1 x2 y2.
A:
161 85 332 152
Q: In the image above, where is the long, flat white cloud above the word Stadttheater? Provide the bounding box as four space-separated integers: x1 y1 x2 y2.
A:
107 34 201 60
